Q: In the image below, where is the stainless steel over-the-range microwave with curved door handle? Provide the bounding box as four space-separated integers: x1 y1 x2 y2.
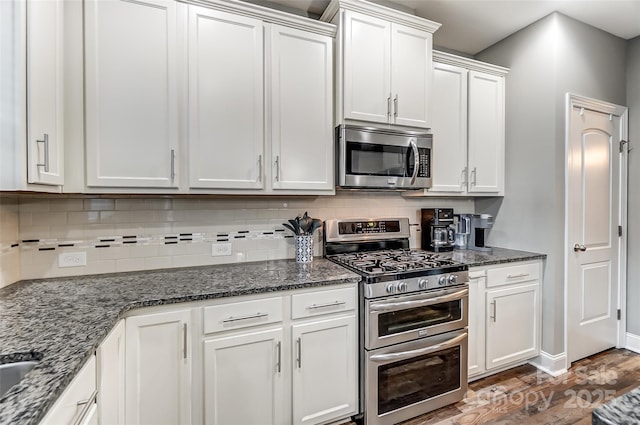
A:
336 125 433 190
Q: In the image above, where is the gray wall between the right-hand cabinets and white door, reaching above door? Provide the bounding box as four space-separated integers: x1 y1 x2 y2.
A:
476 13 626 355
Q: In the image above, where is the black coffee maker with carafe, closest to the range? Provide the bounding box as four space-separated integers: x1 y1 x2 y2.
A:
421 208 455 252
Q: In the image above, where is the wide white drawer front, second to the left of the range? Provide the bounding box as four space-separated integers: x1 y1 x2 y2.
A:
203 297 282 334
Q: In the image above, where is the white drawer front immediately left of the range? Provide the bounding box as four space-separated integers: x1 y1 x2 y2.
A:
291 288 357 319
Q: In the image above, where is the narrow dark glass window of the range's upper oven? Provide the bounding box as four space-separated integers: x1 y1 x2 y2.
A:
378 300 462 337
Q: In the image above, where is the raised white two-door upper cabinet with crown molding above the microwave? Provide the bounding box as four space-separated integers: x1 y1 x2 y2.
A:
321 0 440 128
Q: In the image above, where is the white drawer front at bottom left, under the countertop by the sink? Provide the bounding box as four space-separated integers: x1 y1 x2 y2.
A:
40 356 96 425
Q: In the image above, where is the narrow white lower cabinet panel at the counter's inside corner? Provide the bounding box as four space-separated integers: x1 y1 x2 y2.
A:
96 320 125 425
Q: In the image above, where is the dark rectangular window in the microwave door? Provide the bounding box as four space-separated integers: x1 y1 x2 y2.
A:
346 142 413 177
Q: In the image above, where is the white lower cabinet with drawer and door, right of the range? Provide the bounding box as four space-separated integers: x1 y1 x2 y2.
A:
469 261 542 378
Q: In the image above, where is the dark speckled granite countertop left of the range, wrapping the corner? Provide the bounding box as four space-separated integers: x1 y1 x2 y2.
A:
0 258 360 425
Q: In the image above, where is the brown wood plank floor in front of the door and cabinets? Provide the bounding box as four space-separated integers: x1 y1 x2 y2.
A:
350 349 640 425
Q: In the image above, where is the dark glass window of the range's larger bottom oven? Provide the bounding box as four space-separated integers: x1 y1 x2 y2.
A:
378 346 460 415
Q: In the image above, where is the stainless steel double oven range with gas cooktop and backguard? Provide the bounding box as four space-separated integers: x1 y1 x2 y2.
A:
324 218 469 425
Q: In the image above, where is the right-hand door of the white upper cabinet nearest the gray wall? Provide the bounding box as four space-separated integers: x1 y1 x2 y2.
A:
468 71 504 193
